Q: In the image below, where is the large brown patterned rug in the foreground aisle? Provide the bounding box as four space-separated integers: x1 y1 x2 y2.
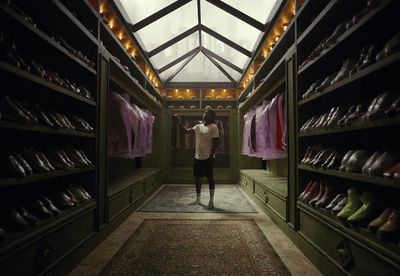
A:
100 219 290 276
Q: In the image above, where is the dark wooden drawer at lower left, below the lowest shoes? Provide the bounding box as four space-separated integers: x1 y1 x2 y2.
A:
0 207 95 276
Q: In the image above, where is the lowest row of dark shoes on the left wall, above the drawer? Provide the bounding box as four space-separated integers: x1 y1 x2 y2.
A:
0 183 92 240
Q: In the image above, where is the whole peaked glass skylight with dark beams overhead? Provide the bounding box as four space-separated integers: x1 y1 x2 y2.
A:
113 0 283 86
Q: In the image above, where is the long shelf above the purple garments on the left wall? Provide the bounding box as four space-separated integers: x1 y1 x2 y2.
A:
110 56 161 110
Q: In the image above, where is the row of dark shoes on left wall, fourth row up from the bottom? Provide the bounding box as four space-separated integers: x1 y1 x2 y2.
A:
0 32 94 100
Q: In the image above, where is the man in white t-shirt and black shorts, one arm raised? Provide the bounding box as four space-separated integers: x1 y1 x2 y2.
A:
175 109 219 209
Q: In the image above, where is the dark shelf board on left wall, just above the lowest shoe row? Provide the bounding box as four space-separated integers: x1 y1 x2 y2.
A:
0 166 96 188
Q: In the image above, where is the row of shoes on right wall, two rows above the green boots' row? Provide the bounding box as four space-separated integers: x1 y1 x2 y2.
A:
300 91 400 133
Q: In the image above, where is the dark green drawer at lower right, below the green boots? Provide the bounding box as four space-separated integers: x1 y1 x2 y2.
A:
299 210 400 275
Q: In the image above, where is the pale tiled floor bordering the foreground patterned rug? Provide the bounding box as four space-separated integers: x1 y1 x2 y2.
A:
70 184 321 276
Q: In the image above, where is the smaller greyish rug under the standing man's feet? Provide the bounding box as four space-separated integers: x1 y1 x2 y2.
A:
139 185 257 213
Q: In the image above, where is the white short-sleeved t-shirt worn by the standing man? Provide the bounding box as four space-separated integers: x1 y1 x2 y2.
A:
192 123 219 160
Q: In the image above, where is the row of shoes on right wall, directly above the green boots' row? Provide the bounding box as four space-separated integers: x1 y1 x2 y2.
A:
300 146 400 179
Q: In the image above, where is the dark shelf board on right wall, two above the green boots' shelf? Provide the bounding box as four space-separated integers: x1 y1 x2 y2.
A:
297 116 400 138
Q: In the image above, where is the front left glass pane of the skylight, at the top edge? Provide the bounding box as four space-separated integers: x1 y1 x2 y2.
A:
114 0 176 24
